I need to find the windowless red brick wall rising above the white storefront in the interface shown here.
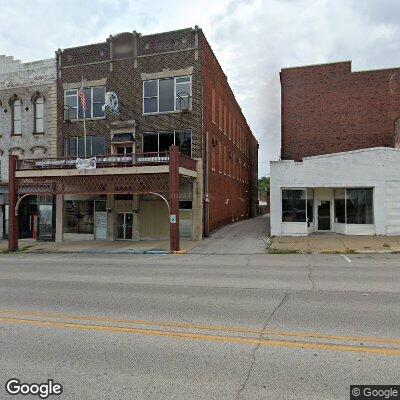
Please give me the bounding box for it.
[280,61,400,161]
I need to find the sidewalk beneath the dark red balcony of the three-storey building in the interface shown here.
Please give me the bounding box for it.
[0,239,198,254]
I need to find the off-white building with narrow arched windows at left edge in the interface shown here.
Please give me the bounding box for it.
[0,56,56,239]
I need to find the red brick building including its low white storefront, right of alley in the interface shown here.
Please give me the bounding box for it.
[271,62,400,236]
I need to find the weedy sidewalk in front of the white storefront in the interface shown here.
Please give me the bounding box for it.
[267,234,400,253]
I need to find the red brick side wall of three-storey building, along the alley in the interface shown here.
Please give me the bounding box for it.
[201,35,258,230]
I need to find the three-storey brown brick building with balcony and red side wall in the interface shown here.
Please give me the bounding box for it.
[9,27,258,250]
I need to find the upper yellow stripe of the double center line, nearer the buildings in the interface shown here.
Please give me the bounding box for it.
[0,310,400,344]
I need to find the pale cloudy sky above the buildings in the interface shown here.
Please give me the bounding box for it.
[0,0,400,175]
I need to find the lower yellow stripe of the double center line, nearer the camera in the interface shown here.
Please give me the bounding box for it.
[0,317,400,356]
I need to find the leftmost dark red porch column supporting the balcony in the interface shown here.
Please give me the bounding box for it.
[8,155,19,252]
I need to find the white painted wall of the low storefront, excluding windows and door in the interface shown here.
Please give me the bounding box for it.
[271,147,400,236]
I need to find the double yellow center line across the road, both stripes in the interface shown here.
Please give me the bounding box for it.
[0,310,400,356]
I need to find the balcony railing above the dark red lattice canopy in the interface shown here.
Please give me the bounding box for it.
[17,151,196,171]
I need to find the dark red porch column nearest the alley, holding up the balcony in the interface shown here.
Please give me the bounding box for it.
[169,146,180,251]
